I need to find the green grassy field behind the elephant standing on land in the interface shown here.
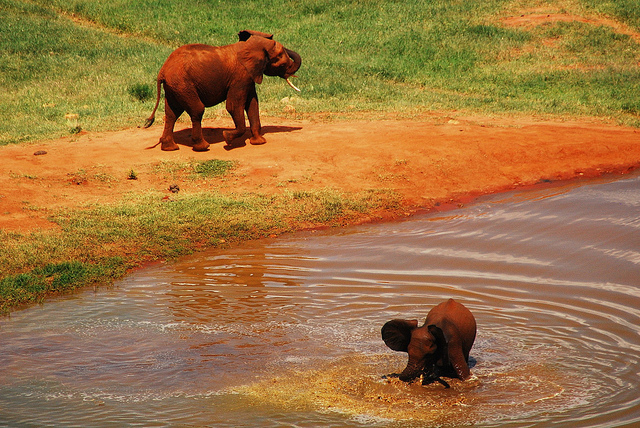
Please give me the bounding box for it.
[0,0,640,144]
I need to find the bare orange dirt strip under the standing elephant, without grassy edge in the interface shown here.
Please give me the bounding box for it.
[0,113,640,232]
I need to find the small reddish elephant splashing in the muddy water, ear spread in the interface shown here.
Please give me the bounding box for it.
[382,299,476,387]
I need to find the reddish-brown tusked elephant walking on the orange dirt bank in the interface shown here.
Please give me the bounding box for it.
[144,30,302,151]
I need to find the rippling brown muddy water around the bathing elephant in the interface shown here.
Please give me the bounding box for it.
[0,175,640,427]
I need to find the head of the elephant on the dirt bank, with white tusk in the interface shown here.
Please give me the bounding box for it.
[238,30,302,91]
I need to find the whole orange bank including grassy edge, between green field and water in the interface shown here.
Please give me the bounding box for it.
[0,112,640,312]
